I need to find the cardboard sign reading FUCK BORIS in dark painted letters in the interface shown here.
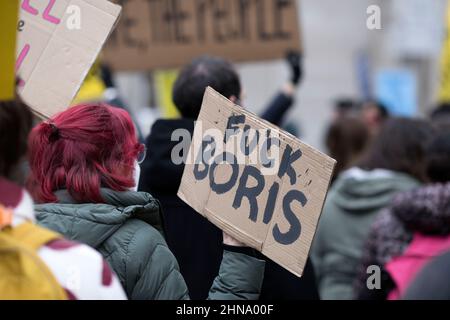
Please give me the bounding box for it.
[178,88,336,276]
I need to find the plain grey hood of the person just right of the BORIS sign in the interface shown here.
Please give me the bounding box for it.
[333,168,419,213]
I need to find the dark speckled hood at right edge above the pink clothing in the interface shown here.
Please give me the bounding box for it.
[391,183,450,235]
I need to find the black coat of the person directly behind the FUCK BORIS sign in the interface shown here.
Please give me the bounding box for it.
[139,95,319,300]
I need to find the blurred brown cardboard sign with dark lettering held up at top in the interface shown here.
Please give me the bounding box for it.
[104,0,301,71]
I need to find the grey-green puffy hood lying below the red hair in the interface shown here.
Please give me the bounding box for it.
[35,189,162,248]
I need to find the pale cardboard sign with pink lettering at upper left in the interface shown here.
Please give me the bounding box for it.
[16,0,121,118]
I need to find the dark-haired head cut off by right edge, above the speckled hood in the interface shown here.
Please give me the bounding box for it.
[426,130,450,183]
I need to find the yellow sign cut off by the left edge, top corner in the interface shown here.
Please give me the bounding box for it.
[0,0,19,100]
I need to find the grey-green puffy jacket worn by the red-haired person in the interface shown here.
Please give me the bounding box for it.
[35,189,264,300]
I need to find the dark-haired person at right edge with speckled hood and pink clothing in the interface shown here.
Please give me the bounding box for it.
[356,131,450,300]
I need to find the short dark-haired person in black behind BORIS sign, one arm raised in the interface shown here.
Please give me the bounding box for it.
[139,53,319,300]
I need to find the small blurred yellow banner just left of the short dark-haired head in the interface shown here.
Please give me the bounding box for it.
[154,70,180,119]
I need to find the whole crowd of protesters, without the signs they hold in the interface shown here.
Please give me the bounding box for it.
[0,52,450,301]
